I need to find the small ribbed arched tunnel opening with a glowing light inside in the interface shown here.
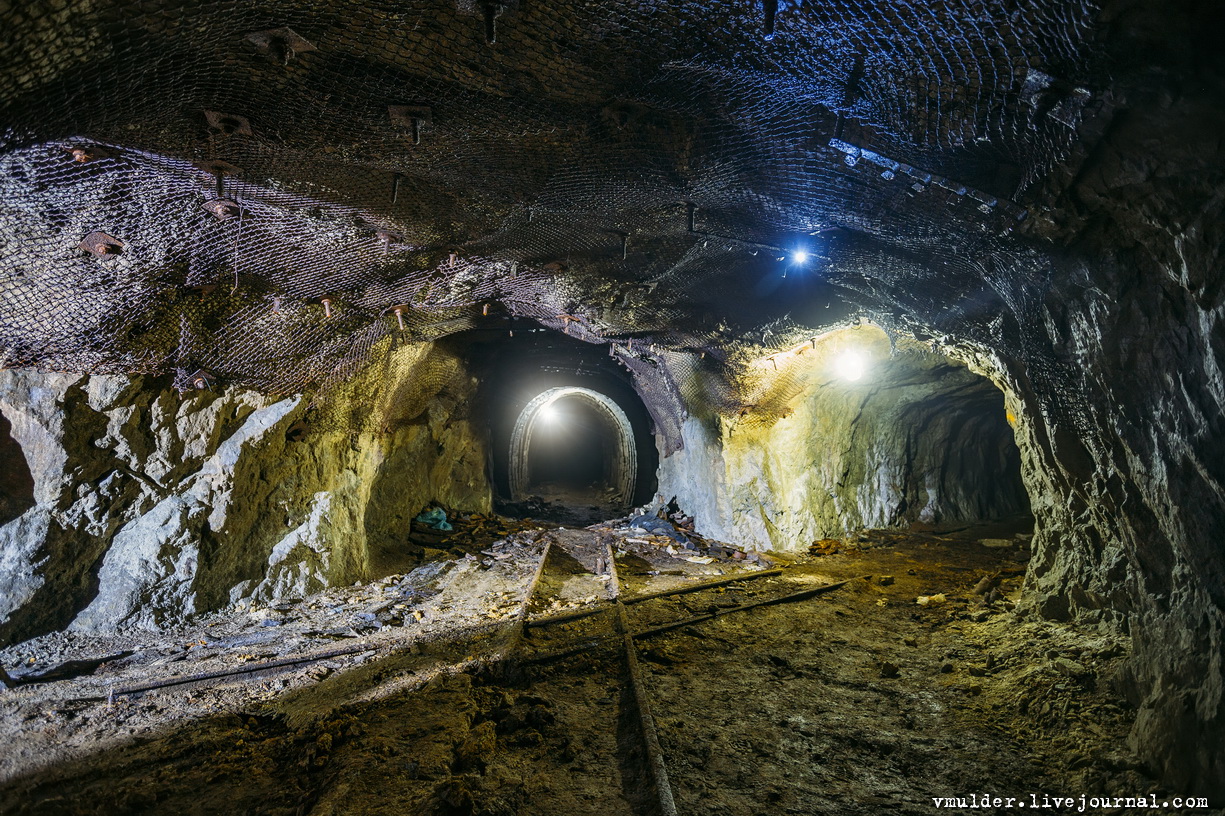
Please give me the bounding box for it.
[508,386,638,510]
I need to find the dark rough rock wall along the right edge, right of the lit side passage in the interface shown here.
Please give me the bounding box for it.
[1008,95,1225,789]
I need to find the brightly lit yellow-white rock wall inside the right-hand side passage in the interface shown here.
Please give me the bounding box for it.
[659,327,1028,550]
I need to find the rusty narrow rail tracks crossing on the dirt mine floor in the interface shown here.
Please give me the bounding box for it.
[19,524,854,816]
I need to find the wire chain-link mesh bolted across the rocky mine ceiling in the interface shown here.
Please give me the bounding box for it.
[0,0,1096,424]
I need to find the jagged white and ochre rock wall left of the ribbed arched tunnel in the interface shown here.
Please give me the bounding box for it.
[0,344,490,642]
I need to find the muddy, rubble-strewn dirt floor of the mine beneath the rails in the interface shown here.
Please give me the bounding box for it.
[0,514,1185,816]
